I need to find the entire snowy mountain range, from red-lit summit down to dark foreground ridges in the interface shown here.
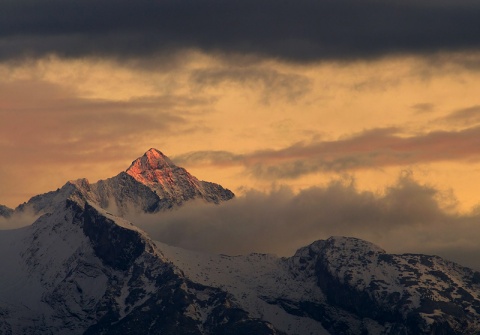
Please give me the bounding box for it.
[0,149,480,335]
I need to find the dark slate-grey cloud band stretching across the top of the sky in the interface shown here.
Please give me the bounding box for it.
[0,0,480,61]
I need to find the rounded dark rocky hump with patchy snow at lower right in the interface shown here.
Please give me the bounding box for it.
[291,237,480,334]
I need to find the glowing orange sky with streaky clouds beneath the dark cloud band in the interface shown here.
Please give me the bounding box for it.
[0,51,480,211]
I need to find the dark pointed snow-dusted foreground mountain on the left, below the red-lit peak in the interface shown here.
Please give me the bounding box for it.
[0,196,279,334]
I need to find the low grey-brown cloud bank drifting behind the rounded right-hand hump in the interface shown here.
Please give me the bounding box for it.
[131,174,480,269]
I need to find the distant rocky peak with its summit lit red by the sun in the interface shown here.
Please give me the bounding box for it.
[16,148,234,215]
